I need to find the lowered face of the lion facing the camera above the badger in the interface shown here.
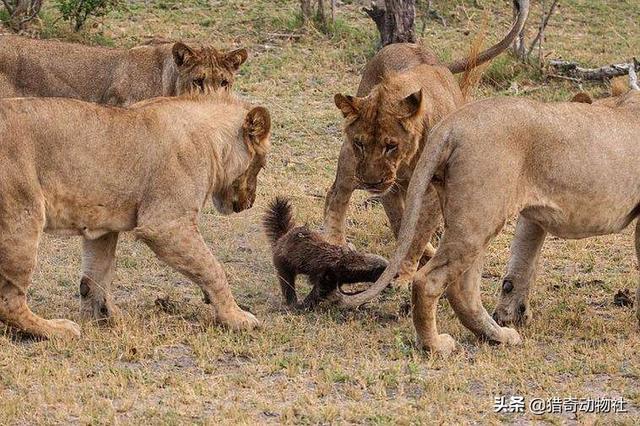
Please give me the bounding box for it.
[334,90,424,194]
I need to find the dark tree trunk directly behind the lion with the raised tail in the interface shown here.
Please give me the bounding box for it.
[364,0,416,46]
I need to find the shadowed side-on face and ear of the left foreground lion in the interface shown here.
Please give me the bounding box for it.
[213,107,271,214]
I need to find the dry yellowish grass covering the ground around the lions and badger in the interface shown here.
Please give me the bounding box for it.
[0,0,640,424]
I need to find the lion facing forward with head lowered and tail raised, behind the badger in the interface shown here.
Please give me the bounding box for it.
[324,0,529,272]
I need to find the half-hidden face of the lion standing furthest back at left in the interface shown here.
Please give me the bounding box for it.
[172,43,247,95]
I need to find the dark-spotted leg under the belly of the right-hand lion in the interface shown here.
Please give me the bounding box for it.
[493,216,547,325]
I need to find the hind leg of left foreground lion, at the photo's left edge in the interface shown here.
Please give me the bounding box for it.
[0,197,80,338]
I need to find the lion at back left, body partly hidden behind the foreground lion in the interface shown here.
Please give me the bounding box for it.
[0,35,247,106]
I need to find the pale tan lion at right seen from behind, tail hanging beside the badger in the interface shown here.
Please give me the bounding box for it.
[341,85,640,354]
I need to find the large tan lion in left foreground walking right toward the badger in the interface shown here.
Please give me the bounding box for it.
[0,95,271,336]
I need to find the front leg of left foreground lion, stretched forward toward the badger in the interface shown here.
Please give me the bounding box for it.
[135,216,258,330]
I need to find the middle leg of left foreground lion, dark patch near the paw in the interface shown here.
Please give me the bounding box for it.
[80,232,118,320]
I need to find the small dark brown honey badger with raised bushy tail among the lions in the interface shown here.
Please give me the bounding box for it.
[263,197,388,309]
